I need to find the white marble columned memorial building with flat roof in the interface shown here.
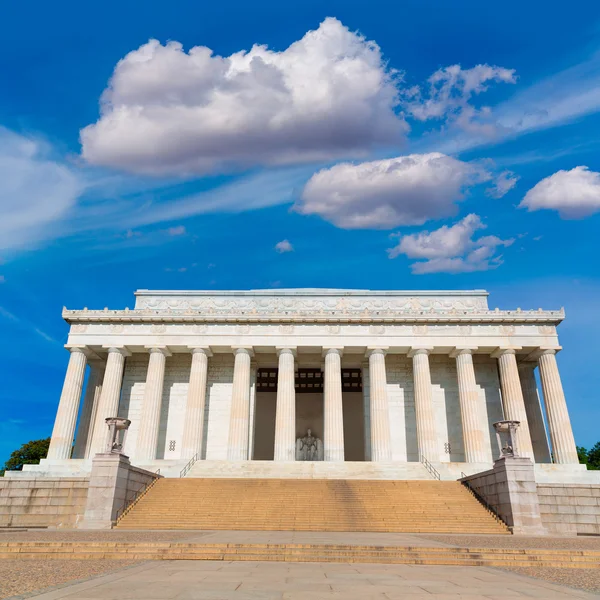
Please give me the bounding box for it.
[36,289,578,478]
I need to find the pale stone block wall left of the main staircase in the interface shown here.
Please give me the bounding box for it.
[0,477,89,527]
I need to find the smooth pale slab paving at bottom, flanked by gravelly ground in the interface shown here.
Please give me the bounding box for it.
[14,561,600,600]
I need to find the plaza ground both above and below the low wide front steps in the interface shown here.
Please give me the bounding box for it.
[0,530,600,600]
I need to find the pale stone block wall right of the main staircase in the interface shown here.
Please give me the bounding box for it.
[537,483,600,535]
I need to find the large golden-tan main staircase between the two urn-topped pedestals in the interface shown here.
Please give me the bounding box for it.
[117,478,509,534]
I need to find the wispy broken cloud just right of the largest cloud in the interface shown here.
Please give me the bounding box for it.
[403,65,516,135]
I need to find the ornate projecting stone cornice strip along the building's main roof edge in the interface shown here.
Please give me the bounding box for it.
[62,308,565,325]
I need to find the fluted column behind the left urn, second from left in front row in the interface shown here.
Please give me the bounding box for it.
[90,348,129,457]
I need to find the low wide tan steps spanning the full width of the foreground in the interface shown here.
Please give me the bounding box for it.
[0,542,600,569]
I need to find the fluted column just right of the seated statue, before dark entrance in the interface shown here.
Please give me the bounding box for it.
[323,348,344,461]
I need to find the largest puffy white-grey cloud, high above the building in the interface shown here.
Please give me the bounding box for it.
[81,18,407,175]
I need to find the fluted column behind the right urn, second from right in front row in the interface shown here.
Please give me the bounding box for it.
[492,348,534,460]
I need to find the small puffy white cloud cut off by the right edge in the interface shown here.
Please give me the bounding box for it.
[519,166,600,219]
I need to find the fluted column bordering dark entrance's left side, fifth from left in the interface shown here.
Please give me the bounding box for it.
[227,348,252,460]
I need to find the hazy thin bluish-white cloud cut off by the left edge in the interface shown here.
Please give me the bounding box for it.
[0,127,83,249]
